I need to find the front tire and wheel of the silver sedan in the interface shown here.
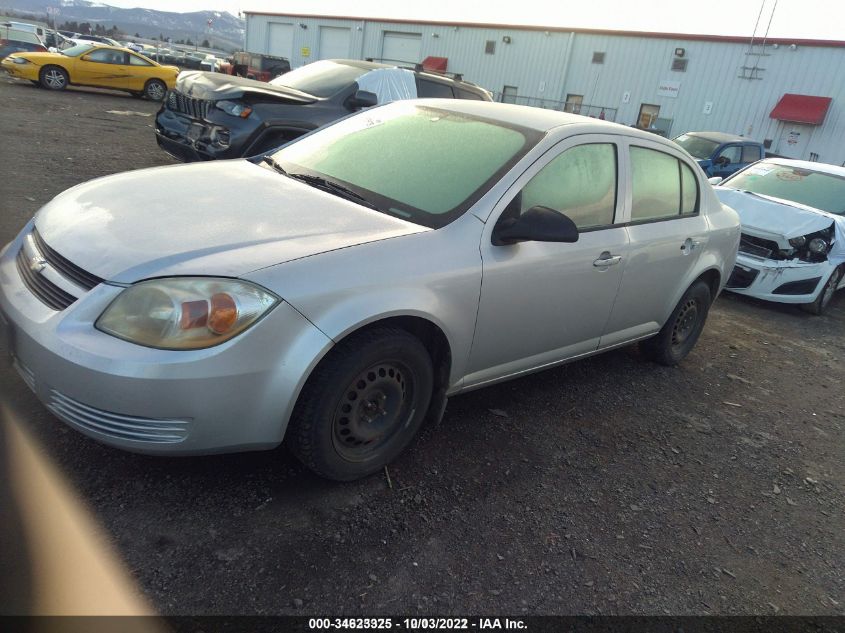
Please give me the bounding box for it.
[286,328,433,481]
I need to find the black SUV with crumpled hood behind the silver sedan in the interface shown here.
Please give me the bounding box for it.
[155,59,492,161]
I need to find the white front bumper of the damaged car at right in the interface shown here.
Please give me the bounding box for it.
[725,252,835,304]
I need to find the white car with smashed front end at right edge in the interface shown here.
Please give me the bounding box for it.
[711,158,845,314]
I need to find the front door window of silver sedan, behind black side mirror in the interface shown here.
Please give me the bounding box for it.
[506,143,616,230]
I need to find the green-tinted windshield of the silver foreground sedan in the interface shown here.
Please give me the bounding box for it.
[273,101,542,228]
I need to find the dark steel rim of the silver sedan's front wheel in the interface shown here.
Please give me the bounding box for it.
[332,361,416,462]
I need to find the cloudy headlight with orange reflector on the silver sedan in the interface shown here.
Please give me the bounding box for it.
[95,277,280,350]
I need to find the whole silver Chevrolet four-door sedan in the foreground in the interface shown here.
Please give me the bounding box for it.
[0,100,740,480]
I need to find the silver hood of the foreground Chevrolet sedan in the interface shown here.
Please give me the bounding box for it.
[35,160,431,283]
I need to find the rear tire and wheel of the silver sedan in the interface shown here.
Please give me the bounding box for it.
[640,281,711,367]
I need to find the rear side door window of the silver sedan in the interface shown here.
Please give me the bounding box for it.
[631,147,698,222]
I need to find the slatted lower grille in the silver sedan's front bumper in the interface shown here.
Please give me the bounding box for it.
[47,389,191,444]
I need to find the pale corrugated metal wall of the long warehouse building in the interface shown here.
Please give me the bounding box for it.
[246,14,845,165]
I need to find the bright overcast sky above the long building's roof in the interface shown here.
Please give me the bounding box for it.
[103,0,845,40]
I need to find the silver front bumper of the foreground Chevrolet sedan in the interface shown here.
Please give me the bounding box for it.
[0,230,331,455]
